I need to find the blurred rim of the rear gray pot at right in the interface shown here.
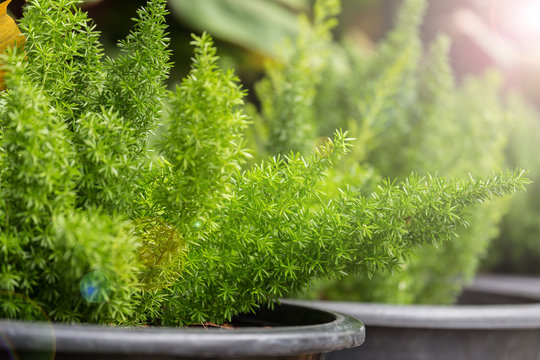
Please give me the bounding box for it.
[288,275,540,330]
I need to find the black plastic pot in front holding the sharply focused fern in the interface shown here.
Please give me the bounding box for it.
[0,303,365,360]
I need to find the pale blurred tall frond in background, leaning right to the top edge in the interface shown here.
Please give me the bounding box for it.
[348,0,427,164]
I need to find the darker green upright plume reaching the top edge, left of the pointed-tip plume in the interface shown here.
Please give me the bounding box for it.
[99,0,171,151]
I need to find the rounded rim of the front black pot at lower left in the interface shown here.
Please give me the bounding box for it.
[0,302,365,357]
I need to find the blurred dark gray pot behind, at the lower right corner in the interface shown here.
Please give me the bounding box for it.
[292,275,540,360]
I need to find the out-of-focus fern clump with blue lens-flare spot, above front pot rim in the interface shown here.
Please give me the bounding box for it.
[49,211,141,323]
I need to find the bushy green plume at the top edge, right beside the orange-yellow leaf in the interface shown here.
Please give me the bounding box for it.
[20,0,103,121]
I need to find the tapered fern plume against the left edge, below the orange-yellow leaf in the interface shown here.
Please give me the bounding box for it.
[0,54,79,234]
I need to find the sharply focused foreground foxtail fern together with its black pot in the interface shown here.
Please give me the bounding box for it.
[0,0,526,358]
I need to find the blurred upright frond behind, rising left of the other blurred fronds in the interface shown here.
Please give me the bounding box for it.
[252,0,340,155]
